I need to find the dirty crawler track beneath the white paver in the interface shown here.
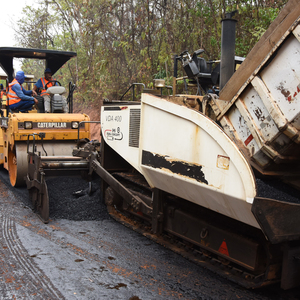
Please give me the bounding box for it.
[105,172,300,288]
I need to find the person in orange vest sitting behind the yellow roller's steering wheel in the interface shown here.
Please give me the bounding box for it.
[33,68,69,113]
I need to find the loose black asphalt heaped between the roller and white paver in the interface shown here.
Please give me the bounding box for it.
[46,177,109,221]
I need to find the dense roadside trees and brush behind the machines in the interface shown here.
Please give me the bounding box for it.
[16,0,287,104]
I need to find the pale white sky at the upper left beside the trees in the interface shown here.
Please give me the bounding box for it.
[0,0,38,73]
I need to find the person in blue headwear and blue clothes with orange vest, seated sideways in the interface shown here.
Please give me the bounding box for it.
[7,71,38,112]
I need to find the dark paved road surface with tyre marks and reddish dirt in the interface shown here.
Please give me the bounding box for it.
[0,170,300,300]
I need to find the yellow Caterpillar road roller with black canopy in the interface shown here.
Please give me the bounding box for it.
[0,47,90,187]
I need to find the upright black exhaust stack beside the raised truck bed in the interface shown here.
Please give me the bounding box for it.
[219,10,237,90]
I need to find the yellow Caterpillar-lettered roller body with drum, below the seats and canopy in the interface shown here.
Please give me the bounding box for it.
[0,112,90,186]
